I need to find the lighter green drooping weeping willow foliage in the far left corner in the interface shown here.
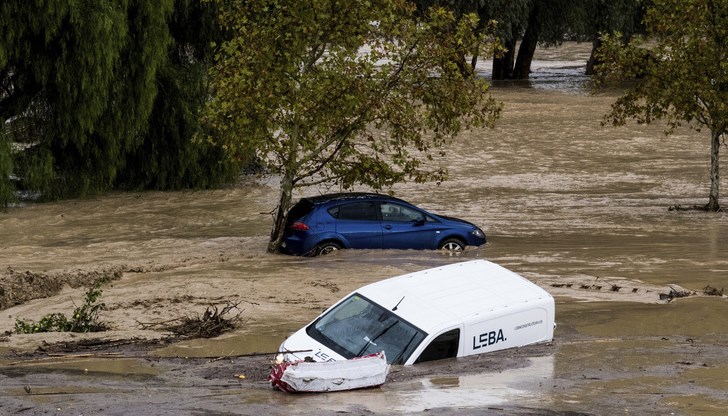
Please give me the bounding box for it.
[0,0,173,198]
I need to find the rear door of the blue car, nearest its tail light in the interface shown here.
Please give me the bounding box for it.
[329,201,382,248]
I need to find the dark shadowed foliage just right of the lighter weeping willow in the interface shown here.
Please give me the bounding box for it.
[116,0,243,190]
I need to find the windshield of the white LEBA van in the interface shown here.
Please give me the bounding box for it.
[306,293,427,364]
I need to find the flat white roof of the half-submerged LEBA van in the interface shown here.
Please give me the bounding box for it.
[357,260,553,333]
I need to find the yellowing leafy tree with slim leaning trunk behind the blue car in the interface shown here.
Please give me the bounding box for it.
[204,0,500,251]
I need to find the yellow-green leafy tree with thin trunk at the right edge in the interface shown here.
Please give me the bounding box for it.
[597,0,728,211]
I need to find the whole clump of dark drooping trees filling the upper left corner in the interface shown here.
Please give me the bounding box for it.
[0,0,240,205]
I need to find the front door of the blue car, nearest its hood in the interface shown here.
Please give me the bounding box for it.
[379,202,439,250]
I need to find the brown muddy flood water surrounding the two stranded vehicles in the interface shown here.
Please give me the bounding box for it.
[0,44,728,415]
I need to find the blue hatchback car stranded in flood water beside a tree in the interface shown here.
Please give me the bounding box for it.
[282,193,485,256]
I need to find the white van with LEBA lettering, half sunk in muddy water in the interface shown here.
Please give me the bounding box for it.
[279,260,555,365]
